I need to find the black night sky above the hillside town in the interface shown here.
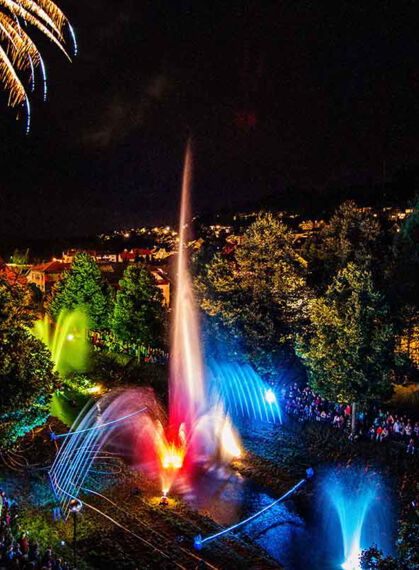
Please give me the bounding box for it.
[0,0,419,237]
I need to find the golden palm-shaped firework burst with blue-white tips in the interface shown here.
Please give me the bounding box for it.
[0,0,76,130]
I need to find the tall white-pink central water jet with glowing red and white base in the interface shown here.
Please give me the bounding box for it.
[159,140,246,490]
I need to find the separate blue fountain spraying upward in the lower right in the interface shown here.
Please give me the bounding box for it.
[320,467,391,570]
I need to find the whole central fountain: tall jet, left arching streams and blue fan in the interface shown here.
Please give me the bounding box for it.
[50,145,280,516]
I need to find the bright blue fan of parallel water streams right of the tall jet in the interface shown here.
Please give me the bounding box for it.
[207,360,282,423]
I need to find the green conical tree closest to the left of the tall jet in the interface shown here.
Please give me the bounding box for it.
[111,264,165,346]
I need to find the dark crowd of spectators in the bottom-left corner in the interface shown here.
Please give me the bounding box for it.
[0,489,72,570]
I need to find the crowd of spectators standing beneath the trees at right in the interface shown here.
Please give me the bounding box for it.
[283,383,419,455]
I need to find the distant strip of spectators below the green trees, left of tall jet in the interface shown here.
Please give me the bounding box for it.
[89,331,169,364]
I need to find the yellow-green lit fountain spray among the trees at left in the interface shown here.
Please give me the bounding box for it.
[33,309,88,375]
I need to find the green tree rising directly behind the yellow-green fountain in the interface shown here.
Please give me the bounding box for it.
[47,253,113,330]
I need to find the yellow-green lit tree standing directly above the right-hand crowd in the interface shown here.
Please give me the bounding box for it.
[297,263,395,404]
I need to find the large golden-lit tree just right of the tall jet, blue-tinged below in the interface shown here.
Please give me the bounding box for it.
[196,214,308,373]
